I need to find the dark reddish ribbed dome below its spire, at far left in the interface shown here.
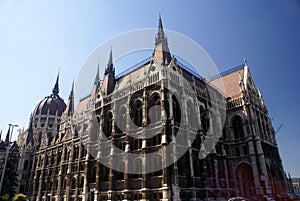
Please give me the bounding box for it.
[34,94,66,116]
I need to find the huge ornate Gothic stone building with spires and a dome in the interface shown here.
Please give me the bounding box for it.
[17,18,287,201]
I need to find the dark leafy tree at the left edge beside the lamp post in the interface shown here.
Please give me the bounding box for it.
[0,146,19,198]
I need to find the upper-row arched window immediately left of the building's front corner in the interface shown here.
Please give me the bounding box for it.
[148,93,161,123]
